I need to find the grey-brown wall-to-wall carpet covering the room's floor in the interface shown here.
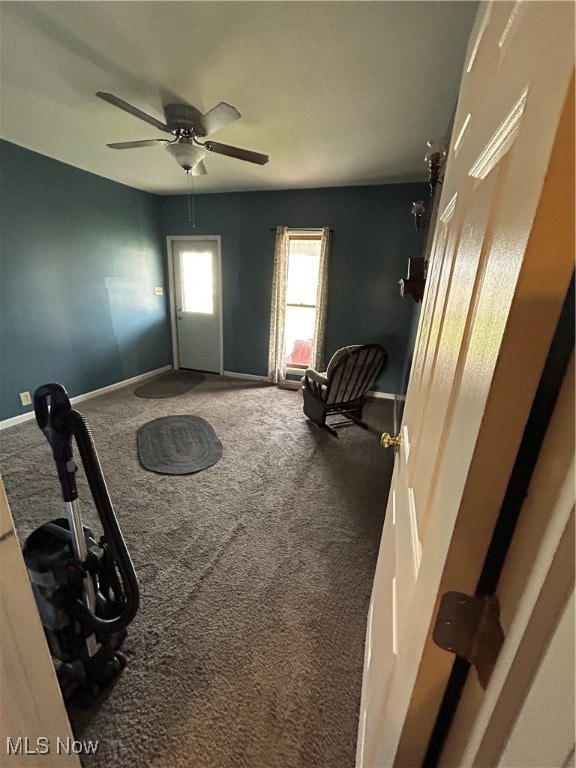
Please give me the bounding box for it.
[0,376,393,768]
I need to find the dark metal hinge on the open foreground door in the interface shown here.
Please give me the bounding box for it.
[432,592,504,688]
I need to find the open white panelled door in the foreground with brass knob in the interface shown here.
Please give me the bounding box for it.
[357,2,574,768]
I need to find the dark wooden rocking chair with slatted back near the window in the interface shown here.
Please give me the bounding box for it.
[302,344,388,435]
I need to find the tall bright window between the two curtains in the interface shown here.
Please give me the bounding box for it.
[284,233,321,369]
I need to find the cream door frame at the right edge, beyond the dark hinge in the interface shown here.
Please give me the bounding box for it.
[439,352,575,768]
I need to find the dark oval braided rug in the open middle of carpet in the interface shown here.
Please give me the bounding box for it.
[136,416,222,475]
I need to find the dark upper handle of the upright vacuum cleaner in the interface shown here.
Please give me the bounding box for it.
[34,384,78,501]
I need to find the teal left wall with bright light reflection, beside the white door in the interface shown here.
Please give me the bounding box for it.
[0,142,171,419]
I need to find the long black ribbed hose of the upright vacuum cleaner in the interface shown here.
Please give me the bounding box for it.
[58,409,140,632]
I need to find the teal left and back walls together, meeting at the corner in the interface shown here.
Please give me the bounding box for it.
[0,141,427,419]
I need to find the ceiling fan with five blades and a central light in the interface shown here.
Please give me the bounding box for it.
[96,91,268,176]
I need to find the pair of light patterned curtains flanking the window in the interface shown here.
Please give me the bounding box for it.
[268,227,330,384]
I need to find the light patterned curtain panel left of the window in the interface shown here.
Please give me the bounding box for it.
[268,227,289,384]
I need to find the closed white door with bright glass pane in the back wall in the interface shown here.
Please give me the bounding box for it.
[169,237,223,373]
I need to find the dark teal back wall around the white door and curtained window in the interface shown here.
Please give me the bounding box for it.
[160,183,428,392]
